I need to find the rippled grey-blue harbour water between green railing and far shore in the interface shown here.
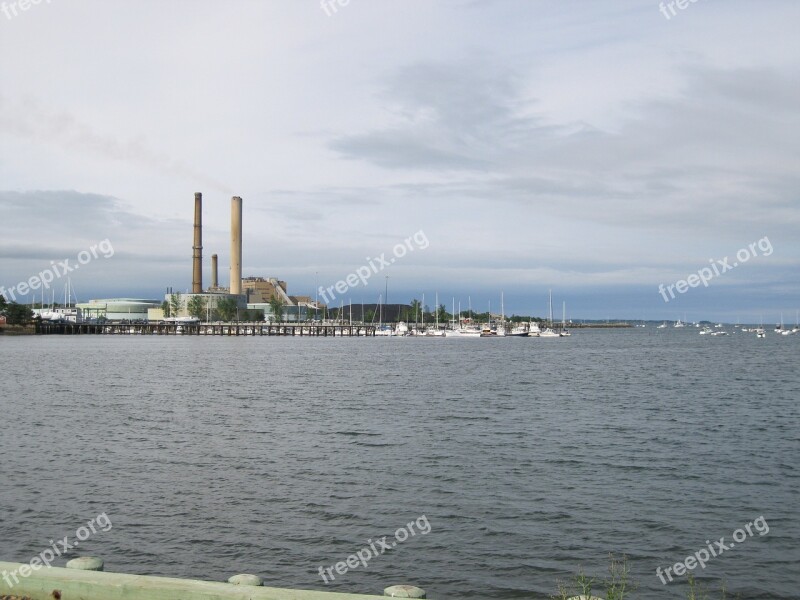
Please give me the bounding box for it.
[0,329,800,599]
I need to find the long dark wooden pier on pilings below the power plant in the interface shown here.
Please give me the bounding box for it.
[34,321,375,337]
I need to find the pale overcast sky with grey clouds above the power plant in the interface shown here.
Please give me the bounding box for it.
[0,0,800,323]
